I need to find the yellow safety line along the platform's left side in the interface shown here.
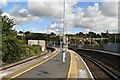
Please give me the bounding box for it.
[10,49,60,79]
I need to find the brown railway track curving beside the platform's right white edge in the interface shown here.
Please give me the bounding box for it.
[71,50,120,80]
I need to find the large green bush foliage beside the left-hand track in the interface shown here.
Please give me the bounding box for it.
[0,13,41,63]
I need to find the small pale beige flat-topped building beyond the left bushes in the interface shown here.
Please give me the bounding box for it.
[28,40,46,51]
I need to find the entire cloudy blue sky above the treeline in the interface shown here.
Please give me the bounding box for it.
[0,0,118,34]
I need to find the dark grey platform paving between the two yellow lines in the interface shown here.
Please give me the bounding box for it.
[12,51,70,80]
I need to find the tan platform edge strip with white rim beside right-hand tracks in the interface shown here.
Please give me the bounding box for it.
[67,50,93,80]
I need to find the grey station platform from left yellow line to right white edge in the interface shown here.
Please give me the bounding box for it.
[2,50,93,80]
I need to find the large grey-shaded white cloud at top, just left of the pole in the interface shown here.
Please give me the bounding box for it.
[28,0,63,18]
